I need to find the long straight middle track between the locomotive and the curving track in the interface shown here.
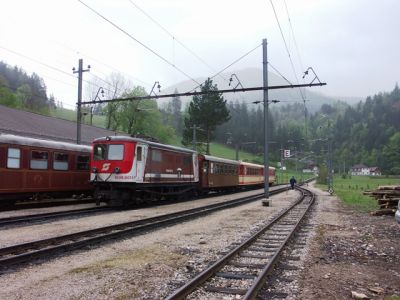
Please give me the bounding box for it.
[0,187,287,271]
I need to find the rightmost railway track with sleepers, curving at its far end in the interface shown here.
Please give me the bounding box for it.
[167,187,314,300]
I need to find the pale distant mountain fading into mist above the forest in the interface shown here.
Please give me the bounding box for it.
[160,68,361,112]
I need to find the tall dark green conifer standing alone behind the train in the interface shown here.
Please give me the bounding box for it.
[182,78,230,154]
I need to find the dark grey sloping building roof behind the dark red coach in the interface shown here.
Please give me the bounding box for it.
[0,105,120,145]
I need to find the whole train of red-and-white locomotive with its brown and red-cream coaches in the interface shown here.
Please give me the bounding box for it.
[91,136,275,206]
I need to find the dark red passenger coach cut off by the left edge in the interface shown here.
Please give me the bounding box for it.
[0,134,92,204]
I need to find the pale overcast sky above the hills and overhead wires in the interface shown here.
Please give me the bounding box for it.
[0,0,400,108]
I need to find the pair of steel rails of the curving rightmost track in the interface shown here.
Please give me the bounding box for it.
[166,187,314,300]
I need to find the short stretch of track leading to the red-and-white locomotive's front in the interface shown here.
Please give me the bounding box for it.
[0,207,115,227]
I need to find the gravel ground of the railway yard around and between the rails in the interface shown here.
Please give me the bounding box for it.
[0,184,400,299]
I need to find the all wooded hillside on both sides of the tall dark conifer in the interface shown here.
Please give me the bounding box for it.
[0,62,400,175]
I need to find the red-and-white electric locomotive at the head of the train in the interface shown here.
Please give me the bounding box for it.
[91,136,199,205]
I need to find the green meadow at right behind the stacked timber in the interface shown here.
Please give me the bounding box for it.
[319,176,400,212]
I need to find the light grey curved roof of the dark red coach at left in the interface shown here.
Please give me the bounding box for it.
[0,134,92,152]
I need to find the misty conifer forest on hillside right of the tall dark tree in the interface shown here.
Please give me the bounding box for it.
[216,85,400,174]
